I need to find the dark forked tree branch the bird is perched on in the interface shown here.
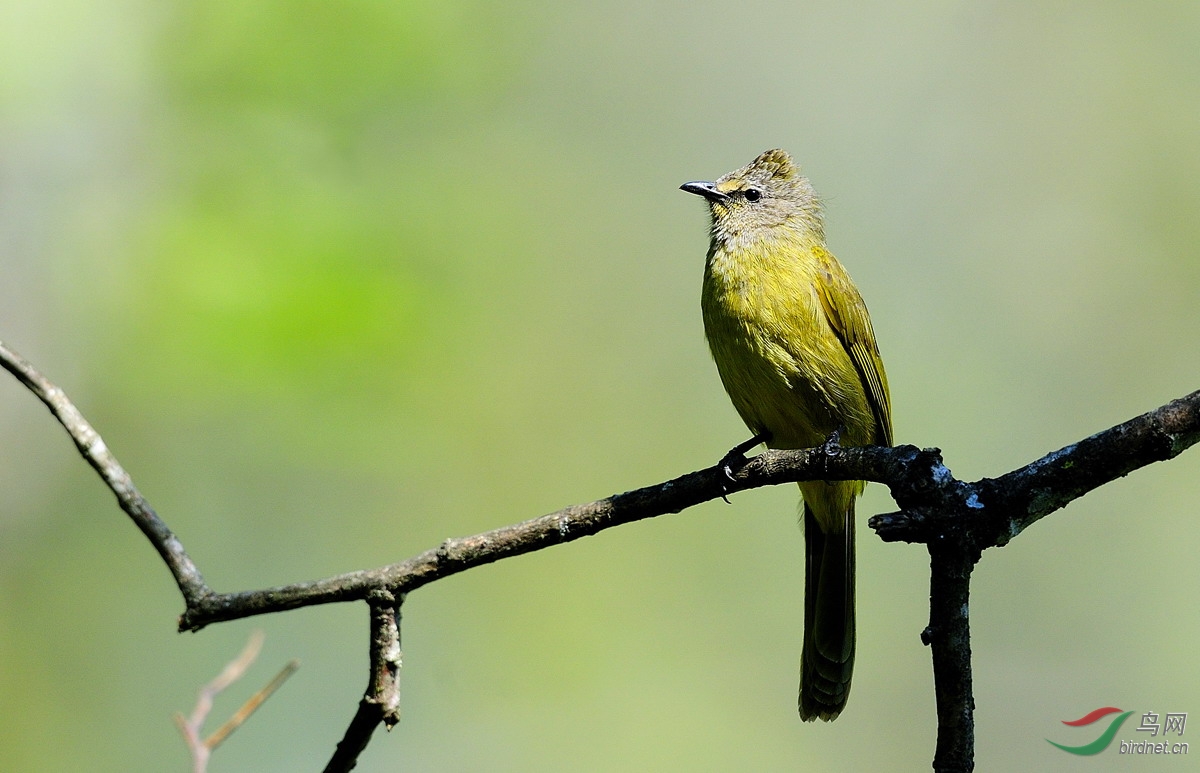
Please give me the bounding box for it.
[0,343,1200,772]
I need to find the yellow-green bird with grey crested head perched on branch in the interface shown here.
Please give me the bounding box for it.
[680,150,892,720]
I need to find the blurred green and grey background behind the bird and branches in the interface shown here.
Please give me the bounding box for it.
[0,0,1200,773]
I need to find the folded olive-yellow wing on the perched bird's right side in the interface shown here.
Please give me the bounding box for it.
[812,246,892,445]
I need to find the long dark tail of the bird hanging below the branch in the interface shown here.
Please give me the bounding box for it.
[800,499,854,721]
